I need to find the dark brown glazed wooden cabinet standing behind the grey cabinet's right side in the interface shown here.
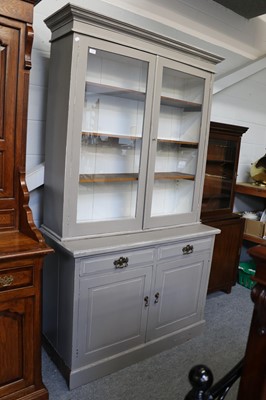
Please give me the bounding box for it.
[201,122,248,293]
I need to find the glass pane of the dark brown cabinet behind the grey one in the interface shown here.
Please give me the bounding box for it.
[202,139,236,211]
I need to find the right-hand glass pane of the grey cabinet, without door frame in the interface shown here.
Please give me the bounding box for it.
[151,68,205,216]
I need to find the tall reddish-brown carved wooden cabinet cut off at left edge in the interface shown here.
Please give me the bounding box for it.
[0,0,51,400]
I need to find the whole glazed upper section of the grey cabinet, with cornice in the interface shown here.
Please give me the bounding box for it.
[44,5,220,238]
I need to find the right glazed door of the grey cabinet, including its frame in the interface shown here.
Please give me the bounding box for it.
[145,59,209,227]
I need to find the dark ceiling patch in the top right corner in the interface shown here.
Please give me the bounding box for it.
[214,0,266,19]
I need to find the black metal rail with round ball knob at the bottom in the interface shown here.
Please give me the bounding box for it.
[184,359,244,400]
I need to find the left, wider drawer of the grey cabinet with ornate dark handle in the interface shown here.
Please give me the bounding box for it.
[80,249,154,276]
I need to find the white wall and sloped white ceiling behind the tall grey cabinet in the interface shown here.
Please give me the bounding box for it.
[26,0,266,225]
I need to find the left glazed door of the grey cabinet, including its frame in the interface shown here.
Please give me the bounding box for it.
[70,40,154,234]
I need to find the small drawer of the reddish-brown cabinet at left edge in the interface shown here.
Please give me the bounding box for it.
[0,266,33,292]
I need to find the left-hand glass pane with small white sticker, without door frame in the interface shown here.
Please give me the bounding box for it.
[77,48,148,222]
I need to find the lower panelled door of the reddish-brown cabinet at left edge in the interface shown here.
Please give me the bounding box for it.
[0,297,34,398]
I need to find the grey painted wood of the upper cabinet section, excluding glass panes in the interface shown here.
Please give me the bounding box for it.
[41,6,218,239]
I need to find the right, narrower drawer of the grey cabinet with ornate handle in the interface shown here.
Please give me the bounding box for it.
[158,238,213,260]
